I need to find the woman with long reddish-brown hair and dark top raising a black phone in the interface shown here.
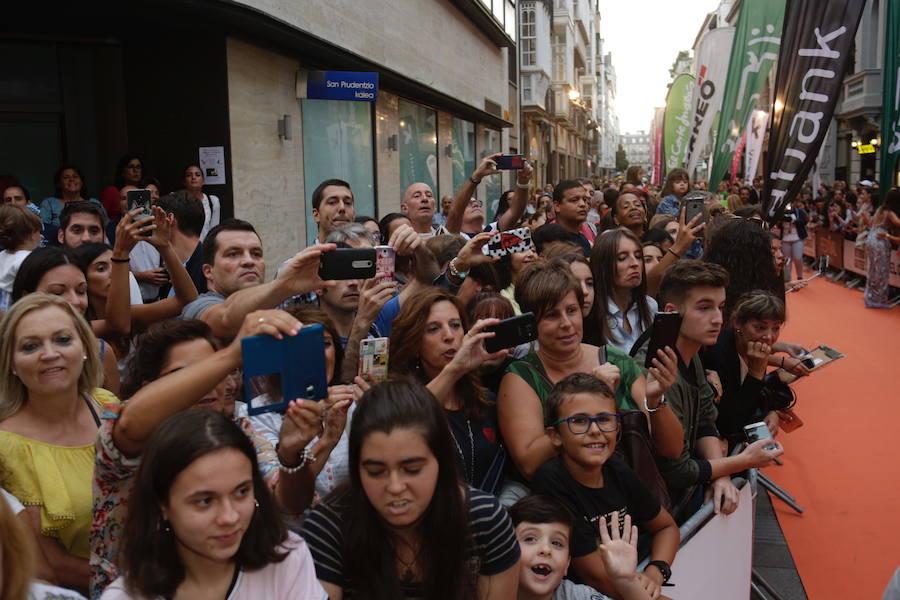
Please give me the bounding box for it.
[388,288,508,494]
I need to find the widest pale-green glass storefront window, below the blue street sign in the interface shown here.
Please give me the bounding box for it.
[300,100,376,244]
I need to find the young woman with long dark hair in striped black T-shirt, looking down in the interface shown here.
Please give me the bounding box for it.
[303,380,519,600]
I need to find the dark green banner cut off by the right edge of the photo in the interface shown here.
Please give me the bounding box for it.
[878,0,900,200]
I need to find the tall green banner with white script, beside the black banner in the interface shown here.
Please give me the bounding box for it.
[709,0,785,190]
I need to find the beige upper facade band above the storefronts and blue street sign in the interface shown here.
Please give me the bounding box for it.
[232,0,509,116]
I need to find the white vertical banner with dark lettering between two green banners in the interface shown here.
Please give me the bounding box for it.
[687,27,734,177]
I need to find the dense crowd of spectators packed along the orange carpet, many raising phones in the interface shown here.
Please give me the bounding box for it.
[0,155,900,600]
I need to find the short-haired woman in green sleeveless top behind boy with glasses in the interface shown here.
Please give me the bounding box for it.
[497,262,683,488]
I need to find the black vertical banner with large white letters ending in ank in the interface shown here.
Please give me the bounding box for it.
[762,0,866,223]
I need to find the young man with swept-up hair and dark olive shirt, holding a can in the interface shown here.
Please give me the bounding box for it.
[634,260,784,514]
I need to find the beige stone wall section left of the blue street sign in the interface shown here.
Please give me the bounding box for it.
[227,38,315,279]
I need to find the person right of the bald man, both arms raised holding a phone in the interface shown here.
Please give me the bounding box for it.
[438,152,534,239]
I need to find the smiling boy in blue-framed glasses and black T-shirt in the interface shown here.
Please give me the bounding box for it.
[532,373,680,597]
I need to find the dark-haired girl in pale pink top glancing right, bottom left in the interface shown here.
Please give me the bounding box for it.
[101,409,327,600]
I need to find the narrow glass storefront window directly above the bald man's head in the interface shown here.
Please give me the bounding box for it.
[399,100,440,198]
